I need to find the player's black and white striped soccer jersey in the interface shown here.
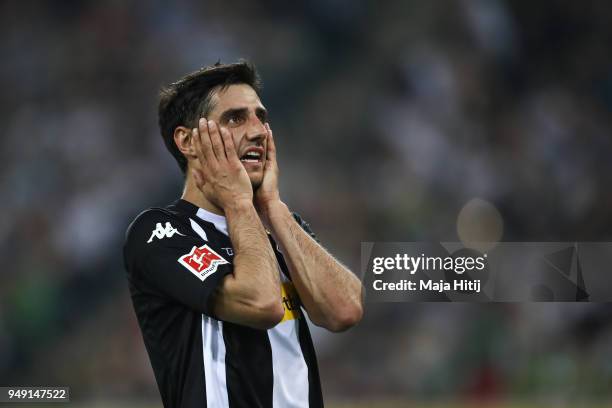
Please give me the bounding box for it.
[124,200,323,408]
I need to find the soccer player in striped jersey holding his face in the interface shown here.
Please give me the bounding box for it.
[124,62,363,408]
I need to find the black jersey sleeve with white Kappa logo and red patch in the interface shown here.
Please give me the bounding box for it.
[124,210,233,317]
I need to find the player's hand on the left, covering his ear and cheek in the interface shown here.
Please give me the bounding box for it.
[191,118,253,209]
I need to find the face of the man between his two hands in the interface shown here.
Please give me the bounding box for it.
[207,84,268,190]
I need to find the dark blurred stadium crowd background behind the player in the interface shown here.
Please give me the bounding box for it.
[0,0,612,407]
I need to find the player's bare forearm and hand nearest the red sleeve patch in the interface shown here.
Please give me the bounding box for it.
[192,120,284,329]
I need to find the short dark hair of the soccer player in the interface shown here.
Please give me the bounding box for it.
[158,60,261,174]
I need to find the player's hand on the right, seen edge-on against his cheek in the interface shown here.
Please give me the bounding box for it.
[253,123,282,225]
